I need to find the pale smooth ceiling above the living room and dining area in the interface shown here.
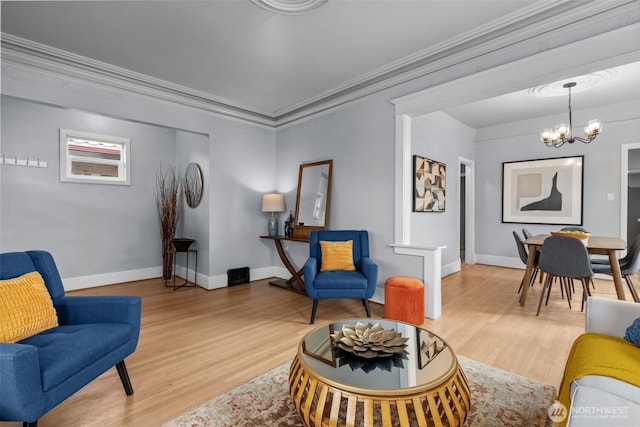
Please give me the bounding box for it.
[1,0,640,128]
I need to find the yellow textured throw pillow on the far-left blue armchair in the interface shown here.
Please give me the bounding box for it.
[0,271,58,342]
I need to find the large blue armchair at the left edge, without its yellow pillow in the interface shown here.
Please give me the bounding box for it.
[0,251,141,426]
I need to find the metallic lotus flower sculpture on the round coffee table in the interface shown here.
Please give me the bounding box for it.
[331,322,409,359]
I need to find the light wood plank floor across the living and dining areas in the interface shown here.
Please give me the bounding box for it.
[0,265,638,427]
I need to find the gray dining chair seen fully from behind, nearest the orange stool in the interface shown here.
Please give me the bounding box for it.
[536,236,593,316]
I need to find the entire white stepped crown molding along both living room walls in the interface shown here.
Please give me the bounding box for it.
[1,0,638,128]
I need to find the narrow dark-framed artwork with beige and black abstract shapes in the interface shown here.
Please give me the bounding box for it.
[413,155,447,212]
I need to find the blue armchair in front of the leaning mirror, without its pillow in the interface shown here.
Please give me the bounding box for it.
[303,230,378,324]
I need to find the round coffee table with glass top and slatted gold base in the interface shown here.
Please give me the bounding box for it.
[289,318,471,427]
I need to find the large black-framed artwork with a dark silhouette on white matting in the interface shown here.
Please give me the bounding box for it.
[502,156,584,225]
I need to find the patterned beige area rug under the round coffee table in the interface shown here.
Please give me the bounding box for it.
[163,356,556,427]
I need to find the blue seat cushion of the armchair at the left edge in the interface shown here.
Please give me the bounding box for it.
[20,323,133,392]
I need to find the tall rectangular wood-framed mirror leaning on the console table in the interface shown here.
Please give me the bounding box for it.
[293,160,333,237]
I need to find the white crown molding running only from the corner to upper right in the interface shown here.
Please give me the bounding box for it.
[274,0,639,127]
